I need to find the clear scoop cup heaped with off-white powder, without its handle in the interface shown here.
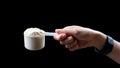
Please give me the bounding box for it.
[24,28,45,50]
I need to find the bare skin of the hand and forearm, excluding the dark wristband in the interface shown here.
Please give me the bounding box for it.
[54,25,120,64]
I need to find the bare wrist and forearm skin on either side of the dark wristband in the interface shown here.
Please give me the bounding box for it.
[95,32,120,64]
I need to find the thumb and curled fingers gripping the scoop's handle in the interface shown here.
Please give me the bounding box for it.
[54,28,85,51]
